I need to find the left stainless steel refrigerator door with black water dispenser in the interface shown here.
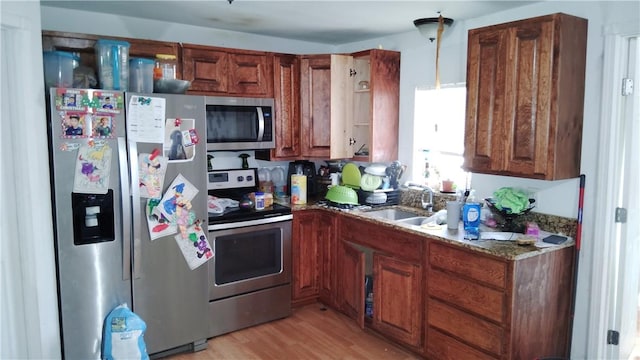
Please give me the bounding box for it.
[48,89,132,359]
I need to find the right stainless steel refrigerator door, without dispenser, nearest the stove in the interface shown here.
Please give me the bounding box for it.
[126,93,207,354]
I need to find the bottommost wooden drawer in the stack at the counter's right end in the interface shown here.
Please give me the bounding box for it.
[427,327,498,360]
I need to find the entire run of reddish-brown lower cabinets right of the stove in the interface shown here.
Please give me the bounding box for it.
[292,209,574,360]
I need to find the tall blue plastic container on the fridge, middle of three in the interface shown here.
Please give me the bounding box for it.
[95,39,130,91]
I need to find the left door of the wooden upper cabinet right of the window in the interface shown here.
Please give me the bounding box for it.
[464,26,508,173]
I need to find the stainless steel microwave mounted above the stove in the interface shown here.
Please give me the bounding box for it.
[206,96,275,151]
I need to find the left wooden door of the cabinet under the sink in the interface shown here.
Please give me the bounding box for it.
[337,241,364,328]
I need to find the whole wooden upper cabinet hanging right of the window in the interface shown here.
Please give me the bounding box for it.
[464,14,587,180]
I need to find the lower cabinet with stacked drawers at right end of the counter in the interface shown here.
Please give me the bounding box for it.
[425,239,573,359]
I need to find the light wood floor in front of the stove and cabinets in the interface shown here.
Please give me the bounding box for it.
[169,304,419,360]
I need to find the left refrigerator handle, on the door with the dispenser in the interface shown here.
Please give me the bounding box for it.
[118,137,131,280]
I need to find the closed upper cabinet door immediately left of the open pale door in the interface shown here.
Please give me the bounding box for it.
[300,55,331,158]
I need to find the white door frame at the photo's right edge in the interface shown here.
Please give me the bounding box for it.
[583,23,640,359]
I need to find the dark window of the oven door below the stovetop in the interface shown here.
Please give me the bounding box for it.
[214,228,282,285]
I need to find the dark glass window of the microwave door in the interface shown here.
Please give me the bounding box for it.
[207,105,258,143]
